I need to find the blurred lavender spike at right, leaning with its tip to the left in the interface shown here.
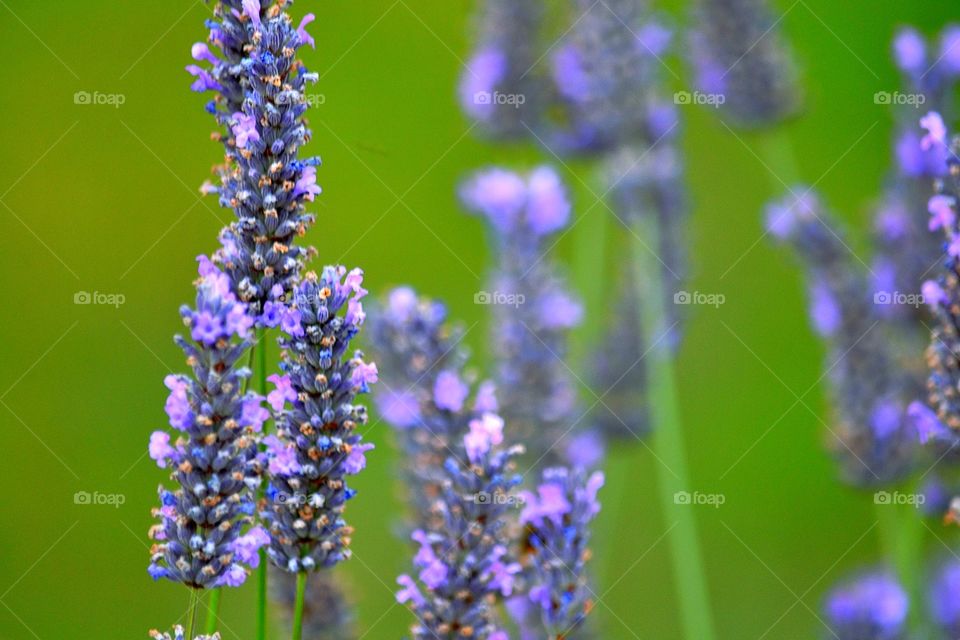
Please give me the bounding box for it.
[767,187,919,486]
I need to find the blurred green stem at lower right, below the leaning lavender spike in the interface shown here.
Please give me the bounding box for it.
[874,489,927,638]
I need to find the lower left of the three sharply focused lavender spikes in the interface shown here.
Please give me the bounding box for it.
[149,256,269,589]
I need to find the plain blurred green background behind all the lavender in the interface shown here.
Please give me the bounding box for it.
[0,0,957,640]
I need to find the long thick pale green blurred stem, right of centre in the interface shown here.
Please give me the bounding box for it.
[630,216,715,640]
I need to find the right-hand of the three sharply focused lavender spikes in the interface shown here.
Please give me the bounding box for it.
[260,267,377,573]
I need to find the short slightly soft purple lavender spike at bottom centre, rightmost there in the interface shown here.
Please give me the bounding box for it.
[520,467,603,640]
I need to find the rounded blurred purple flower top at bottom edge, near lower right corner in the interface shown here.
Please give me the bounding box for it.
[824,573,909,640]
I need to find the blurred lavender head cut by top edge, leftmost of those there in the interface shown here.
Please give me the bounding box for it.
[459,0,544,138]
